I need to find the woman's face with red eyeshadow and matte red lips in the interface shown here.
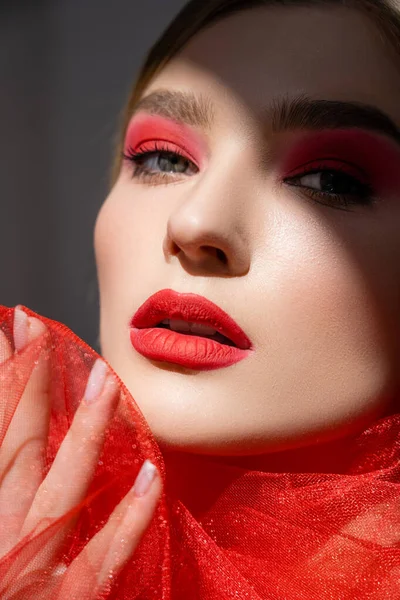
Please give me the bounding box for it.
[95,7,400,455]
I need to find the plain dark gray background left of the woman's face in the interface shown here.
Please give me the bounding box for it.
[0,0,185,347]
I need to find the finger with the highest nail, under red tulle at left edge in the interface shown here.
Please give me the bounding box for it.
[0,307,49,552]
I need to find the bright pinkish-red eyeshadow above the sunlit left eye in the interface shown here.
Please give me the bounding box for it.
[124,113,208,168]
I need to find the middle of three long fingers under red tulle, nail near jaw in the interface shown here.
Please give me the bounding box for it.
[21,359,119,535]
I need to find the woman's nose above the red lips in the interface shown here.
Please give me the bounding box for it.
[163,168,251,277]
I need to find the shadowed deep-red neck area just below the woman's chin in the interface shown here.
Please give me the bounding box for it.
[163,395,398,518]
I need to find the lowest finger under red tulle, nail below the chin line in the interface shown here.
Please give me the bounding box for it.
[57,460,162,600]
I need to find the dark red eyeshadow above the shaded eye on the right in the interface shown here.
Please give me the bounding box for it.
[281,129,400,193]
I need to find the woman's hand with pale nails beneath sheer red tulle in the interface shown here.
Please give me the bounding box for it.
[0,308,162,600]
